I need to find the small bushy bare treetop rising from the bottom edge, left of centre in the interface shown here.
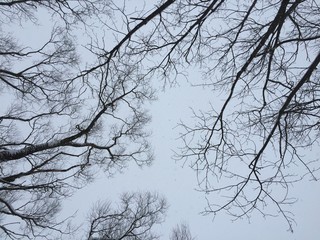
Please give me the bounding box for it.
[88,192,167,240]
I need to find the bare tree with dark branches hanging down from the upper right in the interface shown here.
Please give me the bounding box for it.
[149,0,320,232]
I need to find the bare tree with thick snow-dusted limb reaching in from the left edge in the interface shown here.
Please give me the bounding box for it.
[0,0,165,239]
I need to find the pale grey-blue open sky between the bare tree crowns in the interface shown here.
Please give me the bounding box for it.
[3,0,320,240]
